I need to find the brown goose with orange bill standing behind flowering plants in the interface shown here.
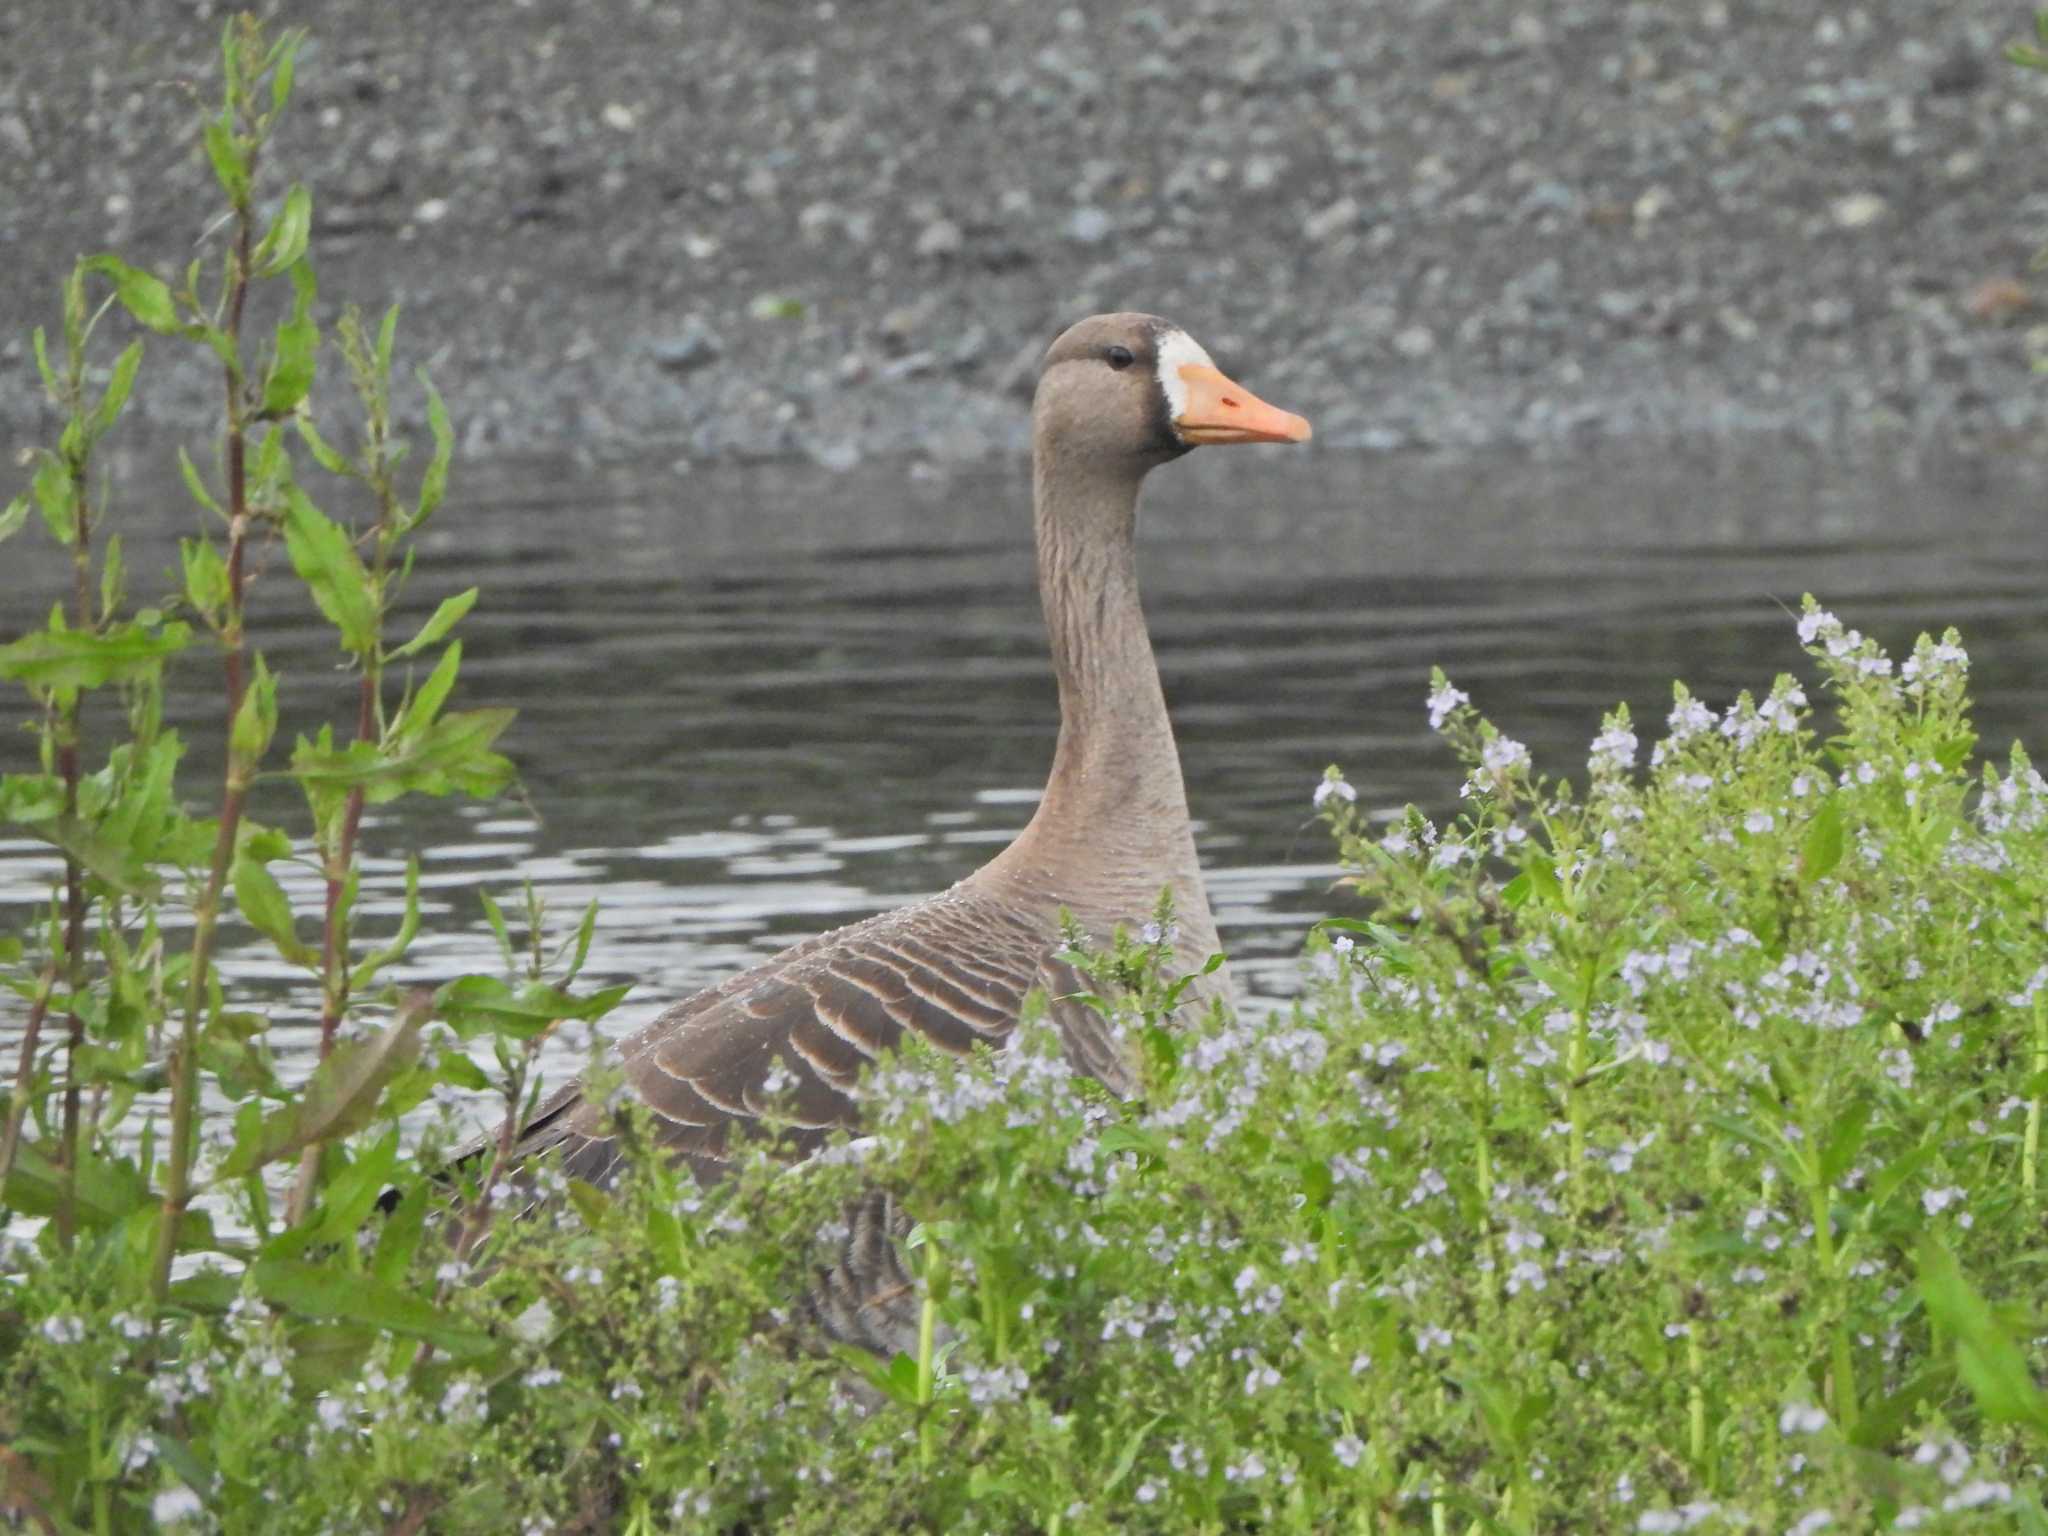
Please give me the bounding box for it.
[497,313,1309,1236]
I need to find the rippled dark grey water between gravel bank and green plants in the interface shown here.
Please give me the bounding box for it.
[0,453,2048,1081]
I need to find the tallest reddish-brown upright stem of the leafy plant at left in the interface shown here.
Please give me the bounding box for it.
[150,189,254,1300]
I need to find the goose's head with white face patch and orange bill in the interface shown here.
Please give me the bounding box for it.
[1032,313,1309,475]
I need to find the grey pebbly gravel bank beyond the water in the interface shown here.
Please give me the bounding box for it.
[0,0,2048,465]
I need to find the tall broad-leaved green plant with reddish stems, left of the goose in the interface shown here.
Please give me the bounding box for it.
[0,18,623,1530]
